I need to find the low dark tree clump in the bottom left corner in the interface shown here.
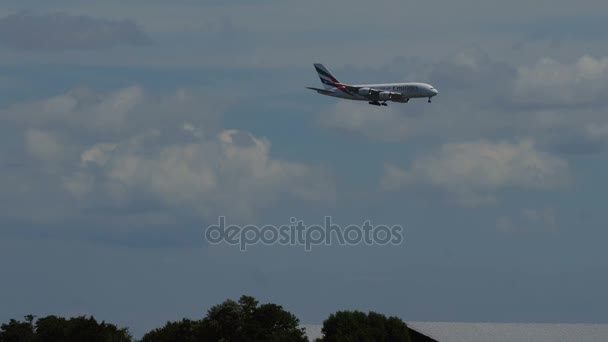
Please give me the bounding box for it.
[0,316,133,342]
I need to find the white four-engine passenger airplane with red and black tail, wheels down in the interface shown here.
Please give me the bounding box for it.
[306,63,439,106]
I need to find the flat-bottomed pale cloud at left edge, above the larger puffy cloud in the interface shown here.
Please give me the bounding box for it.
[0,85,229,144]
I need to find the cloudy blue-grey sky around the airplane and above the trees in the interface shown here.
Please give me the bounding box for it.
[0,0,608,336]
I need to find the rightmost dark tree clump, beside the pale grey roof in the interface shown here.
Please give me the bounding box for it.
[317,311,410,342]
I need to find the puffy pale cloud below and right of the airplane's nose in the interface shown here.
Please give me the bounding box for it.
[382,140,570,205]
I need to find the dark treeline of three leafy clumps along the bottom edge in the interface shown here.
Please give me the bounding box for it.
[0,296,416,342]
